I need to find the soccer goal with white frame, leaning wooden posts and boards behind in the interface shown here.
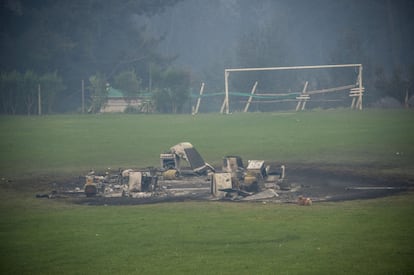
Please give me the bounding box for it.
[220,64,364,114]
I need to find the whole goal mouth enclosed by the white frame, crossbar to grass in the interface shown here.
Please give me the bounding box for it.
[220,64,364,114]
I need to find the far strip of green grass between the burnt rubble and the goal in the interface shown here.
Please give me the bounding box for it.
[0,110,414,176]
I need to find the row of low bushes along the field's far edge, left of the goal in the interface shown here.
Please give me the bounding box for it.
[0,67,191,115]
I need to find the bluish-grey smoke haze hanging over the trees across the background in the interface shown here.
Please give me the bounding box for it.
[0,0,414,113]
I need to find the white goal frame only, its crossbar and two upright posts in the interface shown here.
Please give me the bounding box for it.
[220,64,364,114]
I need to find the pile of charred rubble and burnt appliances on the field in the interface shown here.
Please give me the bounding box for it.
[39,142,309,205]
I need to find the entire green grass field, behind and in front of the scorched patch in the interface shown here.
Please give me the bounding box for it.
[0,110,414,274]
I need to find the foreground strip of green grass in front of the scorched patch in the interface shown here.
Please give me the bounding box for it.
[0,191,414,274]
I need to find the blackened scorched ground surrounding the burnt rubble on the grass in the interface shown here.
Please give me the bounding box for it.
[0,165,414,205]
